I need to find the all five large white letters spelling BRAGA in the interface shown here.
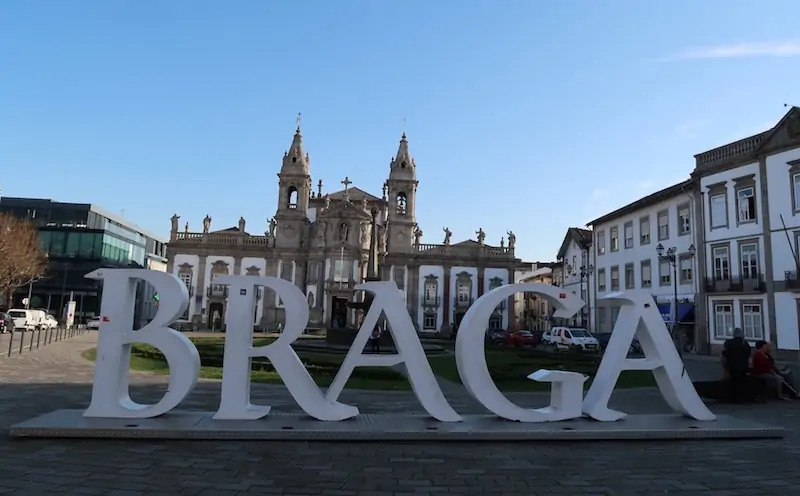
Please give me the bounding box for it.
[84,269,714,422]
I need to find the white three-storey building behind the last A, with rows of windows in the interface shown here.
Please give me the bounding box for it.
[588,180,697,344]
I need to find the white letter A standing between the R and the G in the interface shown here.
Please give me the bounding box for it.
[327,281,461,422]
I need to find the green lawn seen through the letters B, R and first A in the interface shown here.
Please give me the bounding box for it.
[83,338,410,391]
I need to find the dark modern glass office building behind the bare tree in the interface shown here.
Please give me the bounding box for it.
[0,197,166,322]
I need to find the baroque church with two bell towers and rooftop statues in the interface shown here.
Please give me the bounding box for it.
[167,126,521,335]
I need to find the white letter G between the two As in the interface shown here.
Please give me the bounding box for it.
[456,283,585,422]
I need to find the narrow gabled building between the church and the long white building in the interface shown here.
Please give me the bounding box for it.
[557,227,594,327]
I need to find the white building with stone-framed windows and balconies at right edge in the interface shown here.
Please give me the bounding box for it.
[692,107,800,358]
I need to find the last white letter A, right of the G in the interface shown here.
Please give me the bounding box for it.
[583,291,716,422]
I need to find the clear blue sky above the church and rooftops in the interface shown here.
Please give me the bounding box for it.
[0,0,800,260]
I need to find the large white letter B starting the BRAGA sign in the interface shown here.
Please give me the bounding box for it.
[83,269,200,418]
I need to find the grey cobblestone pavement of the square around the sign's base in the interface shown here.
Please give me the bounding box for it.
[0,333,800,496]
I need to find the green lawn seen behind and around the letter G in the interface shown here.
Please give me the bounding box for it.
[429,349,655,391]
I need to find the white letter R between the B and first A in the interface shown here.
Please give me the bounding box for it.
[214,276,358,420]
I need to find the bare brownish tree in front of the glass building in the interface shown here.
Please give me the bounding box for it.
[0,213,47,308]
